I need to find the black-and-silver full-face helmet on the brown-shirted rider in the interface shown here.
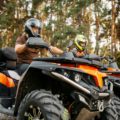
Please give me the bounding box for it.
[24,18,42,37]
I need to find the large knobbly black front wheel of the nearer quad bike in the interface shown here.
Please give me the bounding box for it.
[17,90,69,120]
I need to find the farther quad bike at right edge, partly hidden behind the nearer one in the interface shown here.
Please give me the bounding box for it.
[82,55,120,120]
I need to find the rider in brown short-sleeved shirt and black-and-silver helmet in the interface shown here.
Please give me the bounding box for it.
[15,18,63,74]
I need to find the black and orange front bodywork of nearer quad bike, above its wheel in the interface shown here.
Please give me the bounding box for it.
[15,57,110,114]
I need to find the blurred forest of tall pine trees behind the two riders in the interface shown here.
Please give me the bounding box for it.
[0,0,120,64]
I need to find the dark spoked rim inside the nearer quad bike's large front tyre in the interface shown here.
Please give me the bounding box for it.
[24,105,44,120]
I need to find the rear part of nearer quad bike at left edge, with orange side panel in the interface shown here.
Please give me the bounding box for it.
[0,48,20,115]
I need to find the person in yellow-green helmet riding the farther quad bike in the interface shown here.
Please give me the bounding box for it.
[68,34,87,57]
